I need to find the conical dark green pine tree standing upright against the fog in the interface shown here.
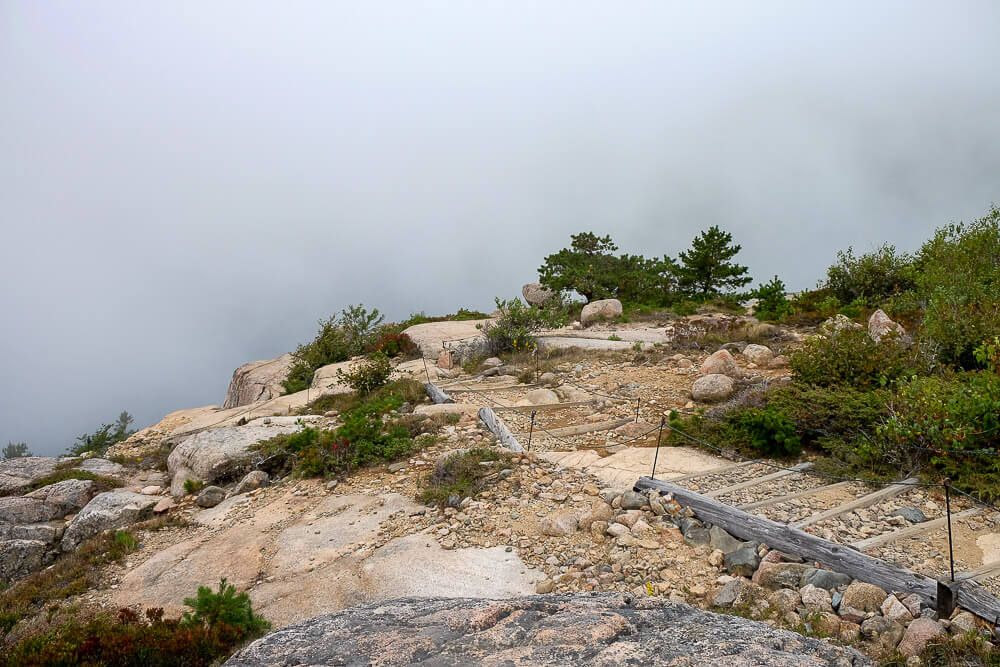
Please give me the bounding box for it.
[677,226,751,298]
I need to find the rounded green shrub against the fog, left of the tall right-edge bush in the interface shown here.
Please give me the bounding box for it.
[824,245,916,304]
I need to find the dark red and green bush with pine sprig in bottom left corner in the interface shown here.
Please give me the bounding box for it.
[2,579,270,667]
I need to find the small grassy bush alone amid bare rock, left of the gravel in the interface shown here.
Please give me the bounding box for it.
[418,447,511,507]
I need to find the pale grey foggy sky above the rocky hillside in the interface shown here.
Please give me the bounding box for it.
[0,0,1000,454]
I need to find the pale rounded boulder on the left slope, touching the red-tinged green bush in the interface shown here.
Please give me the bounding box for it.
[167,423,301,496]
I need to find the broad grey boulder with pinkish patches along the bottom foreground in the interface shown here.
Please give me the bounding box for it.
[225,593,869,667]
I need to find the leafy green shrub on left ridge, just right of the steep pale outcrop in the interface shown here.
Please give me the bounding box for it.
[283,304,384,394]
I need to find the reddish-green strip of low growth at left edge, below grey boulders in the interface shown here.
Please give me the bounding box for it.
[0,530,137,634]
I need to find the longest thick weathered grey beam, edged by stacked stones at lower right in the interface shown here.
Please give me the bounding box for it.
[635,477,1000,619]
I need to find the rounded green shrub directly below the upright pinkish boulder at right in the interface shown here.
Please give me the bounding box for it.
[789,329,931,389]
